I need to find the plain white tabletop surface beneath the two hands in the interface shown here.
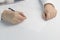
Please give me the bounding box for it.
[0,0,60,40]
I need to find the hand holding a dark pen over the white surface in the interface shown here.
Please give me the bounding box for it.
[1,10,26,24]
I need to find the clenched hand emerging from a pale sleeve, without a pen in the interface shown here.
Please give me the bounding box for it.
[42,3,57,20]
